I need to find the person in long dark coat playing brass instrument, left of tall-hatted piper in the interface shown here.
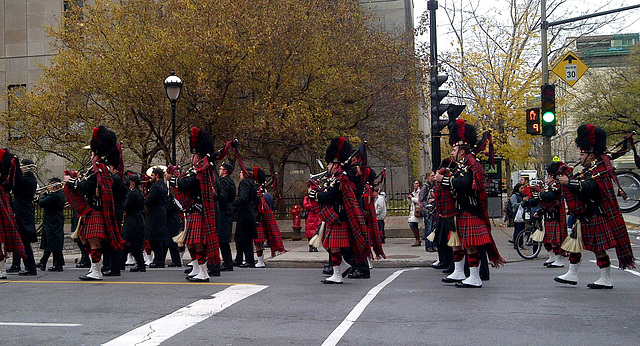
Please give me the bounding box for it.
[38,178,66,272]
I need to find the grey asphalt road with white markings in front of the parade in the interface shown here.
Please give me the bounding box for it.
[0,248,640,345]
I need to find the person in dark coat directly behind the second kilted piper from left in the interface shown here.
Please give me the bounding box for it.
[122,174,146,272]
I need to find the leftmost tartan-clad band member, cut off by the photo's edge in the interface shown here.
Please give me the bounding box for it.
[0,149,26,279]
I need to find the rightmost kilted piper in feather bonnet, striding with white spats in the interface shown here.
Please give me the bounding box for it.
[554,124,635,289]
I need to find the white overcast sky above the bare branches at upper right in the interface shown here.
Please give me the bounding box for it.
[413,0,640,49]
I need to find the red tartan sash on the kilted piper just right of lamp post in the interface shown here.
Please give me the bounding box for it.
[195,157,220,264]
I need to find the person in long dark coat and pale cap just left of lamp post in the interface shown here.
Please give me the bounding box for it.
[144,168,170,268]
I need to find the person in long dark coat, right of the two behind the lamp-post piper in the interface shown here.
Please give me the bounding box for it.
[233,170,258,268]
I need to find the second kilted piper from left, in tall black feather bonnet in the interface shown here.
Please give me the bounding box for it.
[64,126,123,280]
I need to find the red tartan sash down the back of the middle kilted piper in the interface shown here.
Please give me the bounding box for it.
[339,173,371,261]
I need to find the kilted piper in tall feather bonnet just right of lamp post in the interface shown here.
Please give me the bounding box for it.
[170,126,220,282]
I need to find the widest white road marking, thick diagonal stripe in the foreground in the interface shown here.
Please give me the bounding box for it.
[104,285,268,345]
